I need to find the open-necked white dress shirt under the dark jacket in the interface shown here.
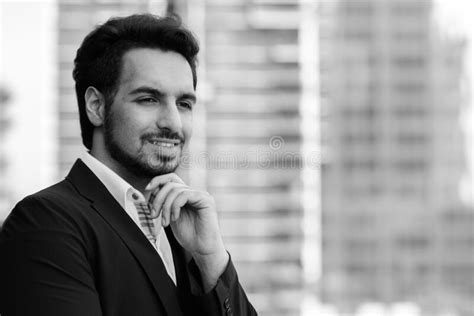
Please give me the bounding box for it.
[81,152,176,284]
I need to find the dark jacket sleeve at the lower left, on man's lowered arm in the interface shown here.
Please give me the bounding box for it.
[0,198,102,316]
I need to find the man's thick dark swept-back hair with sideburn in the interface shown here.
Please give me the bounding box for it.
[73,14,199,149]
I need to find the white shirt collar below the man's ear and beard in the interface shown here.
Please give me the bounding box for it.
[81,152,145,209]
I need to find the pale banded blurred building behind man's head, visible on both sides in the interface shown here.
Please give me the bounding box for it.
[58,0,310,316]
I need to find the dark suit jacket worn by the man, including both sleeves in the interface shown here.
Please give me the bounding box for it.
[0,160,256,316]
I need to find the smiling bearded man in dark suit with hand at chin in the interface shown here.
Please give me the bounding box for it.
[0,14,256,316]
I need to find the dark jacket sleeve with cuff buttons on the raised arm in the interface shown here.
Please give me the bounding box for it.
[185,254,257,316]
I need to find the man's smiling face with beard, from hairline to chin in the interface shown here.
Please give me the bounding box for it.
[104,48,196,178]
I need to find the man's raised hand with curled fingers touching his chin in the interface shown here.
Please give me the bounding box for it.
[146,173,229,291]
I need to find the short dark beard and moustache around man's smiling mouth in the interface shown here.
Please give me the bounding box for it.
[104,107,184,178]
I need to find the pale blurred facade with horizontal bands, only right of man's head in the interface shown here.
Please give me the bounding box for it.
[201,0,306,316]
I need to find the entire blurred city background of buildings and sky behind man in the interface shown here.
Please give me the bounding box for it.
[0,0,474,316]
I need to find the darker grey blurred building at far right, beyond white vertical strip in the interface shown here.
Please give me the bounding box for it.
[320,0,474,315]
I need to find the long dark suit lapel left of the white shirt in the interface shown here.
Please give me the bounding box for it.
[66,160,181,315]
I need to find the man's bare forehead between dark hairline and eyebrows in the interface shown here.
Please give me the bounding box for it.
[119,48,194,92]
